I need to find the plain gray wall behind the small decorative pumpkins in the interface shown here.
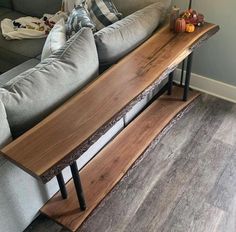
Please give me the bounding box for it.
[173,0,236,86]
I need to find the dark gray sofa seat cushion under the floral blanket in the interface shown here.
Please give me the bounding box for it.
[0,11,45,73]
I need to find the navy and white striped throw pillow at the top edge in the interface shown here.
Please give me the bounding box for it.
[85,0,122,30]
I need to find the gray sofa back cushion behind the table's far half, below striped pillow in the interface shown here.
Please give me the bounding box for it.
[94,3,162,65]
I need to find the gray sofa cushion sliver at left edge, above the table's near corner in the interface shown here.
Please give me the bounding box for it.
[0,101,12,149]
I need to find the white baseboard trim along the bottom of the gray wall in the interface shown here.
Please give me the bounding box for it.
[174,69,236,103]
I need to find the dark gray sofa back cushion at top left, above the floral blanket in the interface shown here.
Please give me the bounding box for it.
[12,0,62,18]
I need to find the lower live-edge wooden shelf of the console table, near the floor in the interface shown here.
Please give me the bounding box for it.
[41,87,199,231]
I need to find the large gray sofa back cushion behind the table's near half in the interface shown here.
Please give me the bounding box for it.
[0,28,99,137]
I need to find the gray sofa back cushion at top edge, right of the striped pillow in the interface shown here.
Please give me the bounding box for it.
[113,0,171,16]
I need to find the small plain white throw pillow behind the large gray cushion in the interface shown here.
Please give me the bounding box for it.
[41,19,66,60]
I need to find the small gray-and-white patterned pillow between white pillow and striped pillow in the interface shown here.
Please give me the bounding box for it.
[66,5,95,38]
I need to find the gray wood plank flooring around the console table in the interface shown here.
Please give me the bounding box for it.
[25,95,236,232]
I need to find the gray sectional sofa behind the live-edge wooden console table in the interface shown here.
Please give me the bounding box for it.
[0,0,170,232]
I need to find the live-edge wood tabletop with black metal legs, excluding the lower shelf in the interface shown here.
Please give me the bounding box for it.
[1,23,219,230]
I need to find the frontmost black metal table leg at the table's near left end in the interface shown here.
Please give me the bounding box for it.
[70,162,86,211]
